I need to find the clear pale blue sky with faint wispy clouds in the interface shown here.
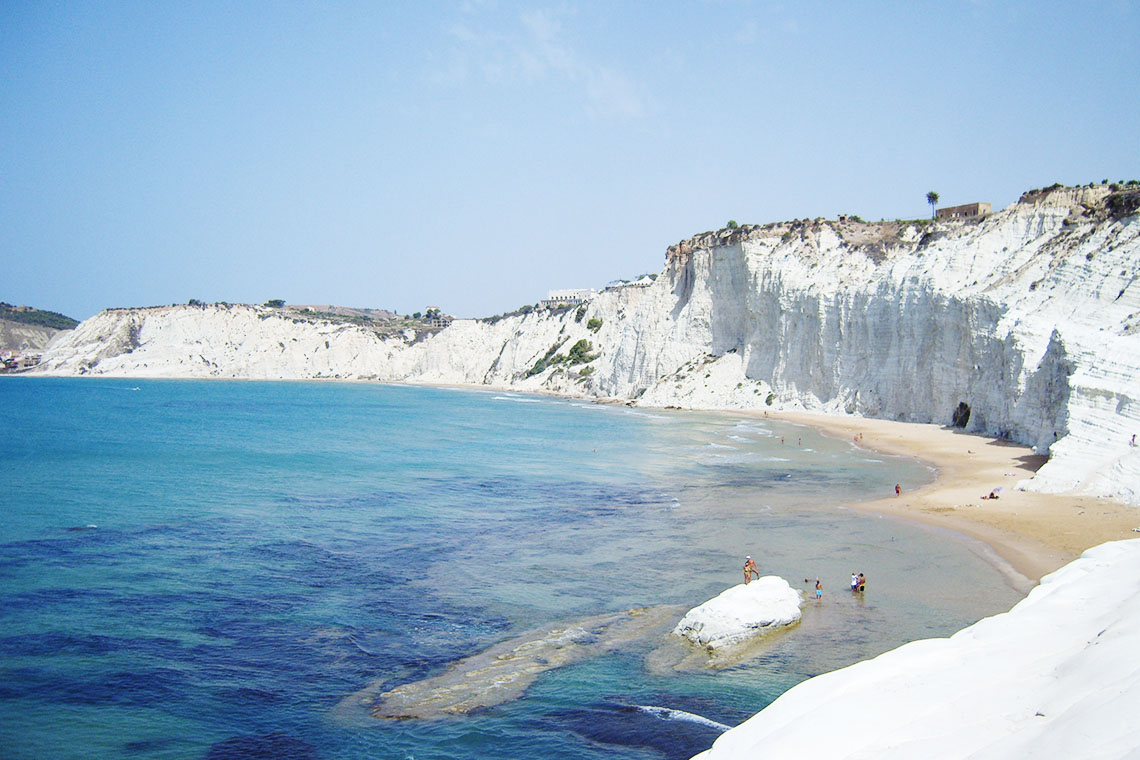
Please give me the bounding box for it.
[0,0,1140,319]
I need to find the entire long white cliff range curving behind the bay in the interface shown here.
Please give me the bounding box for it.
[33,187,1140,504]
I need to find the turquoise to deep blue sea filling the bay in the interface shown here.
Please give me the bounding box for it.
[0,378,1018,760]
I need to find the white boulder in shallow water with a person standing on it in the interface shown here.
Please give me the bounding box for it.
[673,575,803,649]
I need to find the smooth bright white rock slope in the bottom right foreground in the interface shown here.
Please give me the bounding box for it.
[697,540,1140,760]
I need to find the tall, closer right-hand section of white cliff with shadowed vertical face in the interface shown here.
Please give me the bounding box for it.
[624,188,1140,502]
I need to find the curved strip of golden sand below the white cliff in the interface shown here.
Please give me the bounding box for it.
[759,411,1140,582]
